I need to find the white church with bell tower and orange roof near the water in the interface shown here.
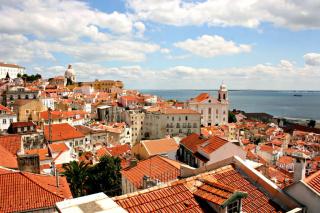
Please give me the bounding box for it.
[186,84,229,126]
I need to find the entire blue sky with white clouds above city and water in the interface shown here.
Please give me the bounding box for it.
[0,0,320,90]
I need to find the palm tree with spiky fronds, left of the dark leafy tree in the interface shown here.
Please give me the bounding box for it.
[62,161,89,197]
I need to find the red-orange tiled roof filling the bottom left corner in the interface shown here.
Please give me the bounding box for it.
[0,172,72,212]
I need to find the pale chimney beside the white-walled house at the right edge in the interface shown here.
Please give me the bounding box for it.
[293,153,309,183]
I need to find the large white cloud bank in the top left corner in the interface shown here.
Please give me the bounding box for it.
[0,0,132,39]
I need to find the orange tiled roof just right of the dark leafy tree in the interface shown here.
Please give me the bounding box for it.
[121,155,180,188]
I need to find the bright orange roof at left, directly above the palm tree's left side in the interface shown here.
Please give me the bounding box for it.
[44,123,84,142]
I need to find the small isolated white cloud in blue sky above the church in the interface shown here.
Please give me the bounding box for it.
[174,35,251,58]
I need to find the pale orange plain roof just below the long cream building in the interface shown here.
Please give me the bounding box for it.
[141,138,179,156]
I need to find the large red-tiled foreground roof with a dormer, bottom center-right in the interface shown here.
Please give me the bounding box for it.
[113,165,282,212]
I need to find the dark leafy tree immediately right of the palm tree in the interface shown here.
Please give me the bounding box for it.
[89,156,121,196]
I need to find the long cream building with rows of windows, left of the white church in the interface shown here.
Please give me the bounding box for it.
[143,108,200,139]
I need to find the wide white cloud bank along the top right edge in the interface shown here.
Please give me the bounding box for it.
[127,0,320,30]
